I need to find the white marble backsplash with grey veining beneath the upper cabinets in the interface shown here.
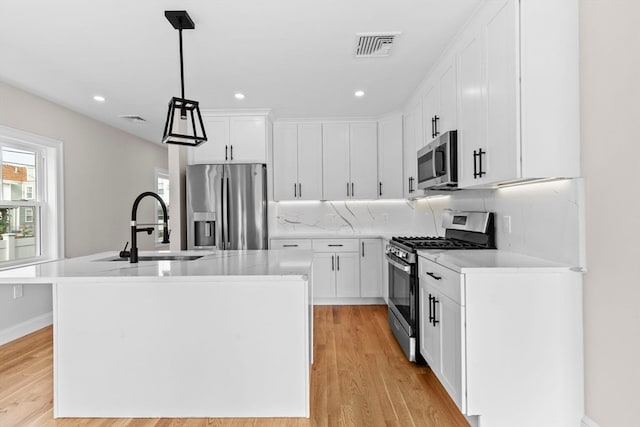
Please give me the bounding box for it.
[269,179,585,267]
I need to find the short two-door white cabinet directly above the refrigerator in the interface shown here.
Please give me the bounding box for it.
[189,111,267,164]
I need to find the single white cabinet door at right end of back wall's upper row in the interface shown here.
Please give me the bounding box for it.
[378,114,403,199]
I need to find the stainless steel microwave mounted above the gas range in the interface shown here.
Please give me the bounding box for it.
[418,130,458,190]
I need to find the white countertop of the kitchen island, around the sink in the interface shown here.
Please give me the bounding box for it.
[0,250,313,283]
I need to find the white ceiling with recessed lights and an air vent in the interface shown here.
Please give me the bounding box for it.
[0,0,481,143]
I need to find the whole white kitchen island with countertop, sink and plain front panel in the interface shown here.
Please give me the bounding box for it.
[0,251,312,418]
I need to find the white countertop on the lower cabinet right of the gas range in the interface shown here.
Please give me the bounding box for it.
[418,249,581,273]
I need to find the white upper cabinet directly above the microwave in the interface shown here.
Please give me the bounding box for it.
[418,61,457,148]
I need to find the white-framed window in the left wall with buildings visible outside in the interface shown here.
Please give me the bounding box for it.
[0,126,64,268]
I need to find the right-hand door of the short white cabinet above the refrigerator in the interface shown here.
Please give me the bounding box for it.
[229,116,267,163]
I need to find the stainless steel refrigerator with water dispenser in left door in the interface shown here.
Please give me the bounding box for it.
[187,163,268,249]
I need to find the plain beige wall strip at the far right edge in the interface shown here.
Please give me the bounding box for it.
[580,0,640,427]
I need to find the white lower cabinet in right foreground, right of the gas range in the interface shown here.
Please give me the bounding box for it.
[418,256,584,427]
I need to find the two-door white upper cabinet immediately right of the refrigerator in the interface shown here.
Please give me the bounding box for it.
[273,122,322,200]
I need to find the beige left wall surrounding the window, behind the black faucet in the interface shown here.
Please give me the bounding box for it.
[0,83,167,257]
